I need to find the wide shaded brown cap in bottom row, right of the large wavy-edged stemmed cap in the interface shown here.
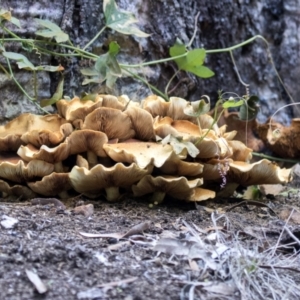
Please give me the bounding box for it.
[132,175,203,200]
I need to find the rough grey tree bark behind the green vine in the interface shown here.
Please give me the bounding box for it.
[0,0,300,123]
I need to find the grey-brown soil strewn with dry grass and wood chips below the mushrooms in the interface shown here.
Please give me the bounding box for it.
[0,177,300,300]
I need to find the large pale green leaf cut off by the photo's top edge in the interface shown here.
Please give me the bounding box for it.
[103,0,149,37]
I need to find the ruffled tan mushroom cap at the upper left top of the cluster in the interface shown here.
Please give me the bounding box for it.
[56,95,102,122]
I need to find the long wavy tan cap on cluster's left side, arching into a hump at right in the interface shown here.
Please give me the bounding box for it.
[17,129,108,163]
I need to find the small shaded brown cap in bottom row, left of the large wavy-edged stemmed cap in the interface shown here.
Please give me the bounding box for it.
[27,172,72,196]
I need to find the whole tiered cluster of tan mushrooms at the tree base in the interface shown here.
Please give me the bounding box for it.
[0,95,290,203]
